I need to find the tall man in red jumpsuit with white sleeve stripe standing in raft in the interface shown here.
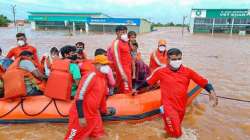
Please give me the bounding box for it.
[111,26,132,93]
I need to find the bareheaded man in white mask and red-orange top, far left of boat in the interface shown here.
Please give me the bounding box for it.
[6,33,39,64]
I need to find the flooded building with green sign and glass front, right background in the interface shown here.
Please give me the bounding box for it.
[189,9,250,34]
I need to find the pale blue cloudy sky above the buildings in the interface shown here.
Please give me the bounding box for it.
[0,0,250,23]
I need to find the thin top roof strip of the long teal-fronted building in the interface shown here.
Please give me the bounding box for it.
[28,12,102,15]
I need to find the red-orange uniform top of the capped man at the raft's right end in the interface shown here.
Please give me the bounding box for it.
[149,49,168,72]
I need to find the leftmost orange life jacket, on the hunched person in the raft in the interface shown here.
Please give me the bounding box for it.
[2,57,45,98]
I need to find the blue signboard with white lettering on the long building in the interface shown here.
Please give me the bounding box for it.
[89,18,140,26]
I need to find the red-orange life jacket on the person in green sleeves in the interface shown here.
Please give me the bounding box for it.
[44,59,73,100]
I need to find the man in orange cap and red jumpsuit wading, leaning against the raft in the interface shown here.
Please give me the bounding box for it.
[65,55,115,140]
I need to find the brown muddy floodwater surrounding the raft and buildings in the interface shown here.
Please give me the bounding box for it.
[0,25,250,140]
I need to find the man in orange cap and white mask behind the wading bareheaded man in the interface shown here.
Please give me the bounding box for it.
[149,39,168,72]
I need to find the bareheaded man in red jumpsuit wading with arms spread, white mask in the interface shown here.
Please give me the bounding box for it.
[135,48,218,138]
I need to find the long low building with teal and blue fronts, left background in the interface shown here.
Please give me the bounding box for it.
[28,12,151,33]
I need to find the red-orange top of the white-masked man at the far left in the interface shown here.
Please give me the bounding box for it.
[6,44,39,64]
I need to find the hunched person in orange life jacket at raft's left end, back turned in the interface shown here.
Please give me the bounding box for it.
[3,51,47,97]
